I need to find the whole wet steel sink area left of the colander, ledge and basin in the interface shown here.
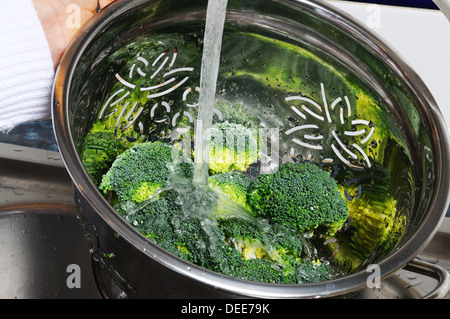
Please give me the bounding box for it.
[0,143,99,299]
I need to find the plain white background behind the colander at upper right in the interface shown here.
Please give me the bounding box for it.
[327,0,450,129]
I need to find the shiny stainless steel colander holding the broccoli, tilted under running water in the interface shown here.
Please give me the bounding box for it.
[53,0,450,298]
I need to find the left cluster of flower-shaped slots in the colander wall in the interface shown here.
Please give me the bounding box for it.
[99,47,222,133]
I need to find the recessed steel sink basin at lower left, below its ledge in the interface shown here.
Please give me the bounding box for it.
[0,205,98,299]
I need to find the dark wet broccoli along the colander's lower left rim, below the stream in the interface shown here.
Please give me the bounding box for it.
[114,189,223,269]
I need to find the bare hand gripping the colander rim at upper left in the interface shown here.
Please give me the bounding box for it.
[33,0,114,69]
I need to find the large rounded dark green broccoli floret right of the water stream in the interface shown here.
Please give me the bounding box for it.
[248,163,348,235]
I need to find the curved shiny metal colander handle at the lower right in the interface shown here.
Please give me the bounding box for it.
[404,258,450,299]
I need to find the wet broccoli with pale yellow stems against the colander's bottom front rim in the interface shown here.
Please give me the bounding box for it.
[219,217,335,283]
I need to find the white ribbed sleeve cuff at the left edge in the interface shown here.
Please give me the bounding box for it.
[0,0,55,131]
